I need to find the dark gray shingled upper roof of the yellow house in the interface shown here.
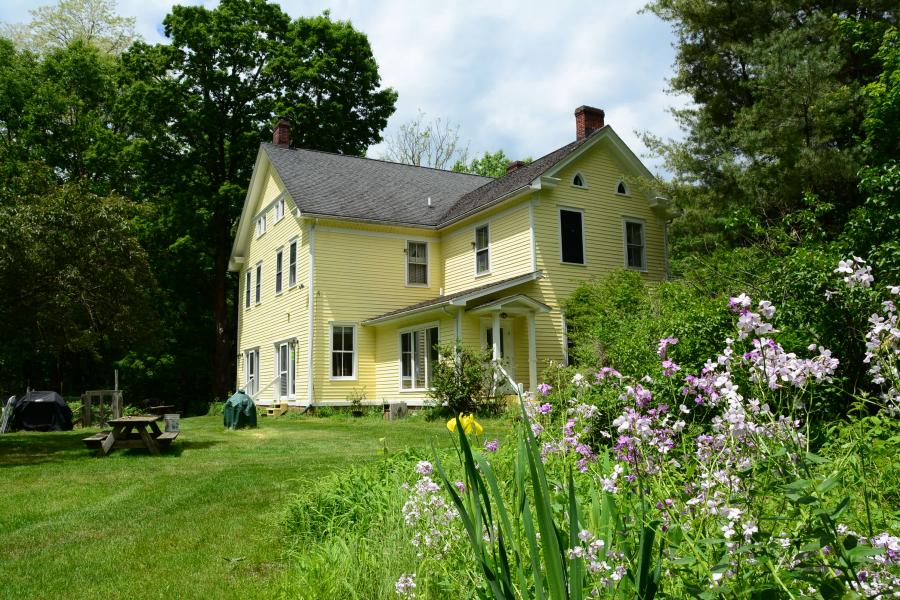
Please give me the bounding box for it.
[262,130,601,227]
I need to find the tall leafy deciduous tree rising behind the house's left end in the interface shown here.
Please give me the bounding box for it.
[123,0,396,398]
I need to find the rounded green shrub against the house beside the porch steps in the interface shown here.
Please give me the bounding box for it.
[428,343,494,415]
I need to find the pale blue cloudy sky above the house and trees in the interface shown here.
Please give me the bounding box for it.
[0,0,686,177]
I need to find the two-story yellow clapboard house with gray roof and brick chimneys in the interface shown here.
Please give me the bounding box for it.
[229,106,668,406]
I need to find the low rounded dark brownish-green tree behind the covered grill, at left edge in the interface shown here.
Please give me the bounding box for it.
[0,173,154,391]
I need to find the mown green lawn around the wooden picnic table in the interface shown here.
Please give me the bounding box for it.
[0,416,468,599]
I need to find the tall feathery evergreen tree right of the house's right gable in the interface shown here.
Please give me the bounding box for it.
[648,0,898,255]
